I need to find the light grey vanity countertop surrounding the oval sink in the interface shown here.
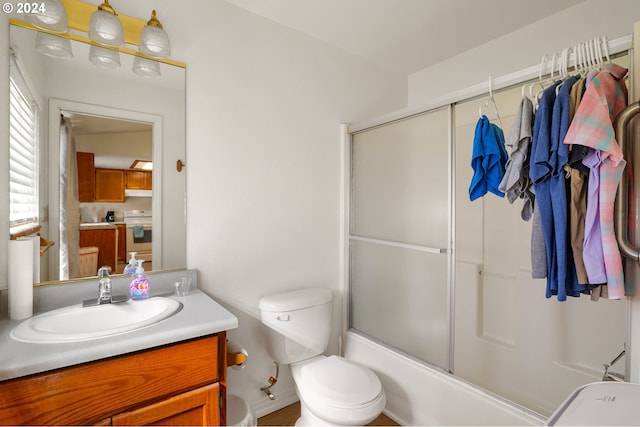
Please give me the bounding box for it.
[0,270,238,381]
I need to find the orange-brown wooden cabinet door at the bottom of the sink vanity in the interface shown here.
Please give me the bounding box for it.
[111,384,220,426]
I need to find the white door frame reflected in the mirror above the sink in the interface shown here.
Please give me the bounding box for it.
[49,98,164,283]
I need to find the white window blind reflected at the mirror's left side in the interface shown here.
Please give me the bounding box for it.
[9,67,38,227]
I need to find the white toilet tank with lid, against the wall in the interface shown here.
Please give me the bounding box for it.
[259,288,333,364]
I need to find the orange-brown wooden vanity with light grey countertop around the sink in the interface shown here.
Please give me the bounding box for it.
[0,271,238,425]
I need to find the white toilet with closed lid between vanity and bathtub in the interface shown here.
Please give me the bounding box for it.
[259,288,387,426]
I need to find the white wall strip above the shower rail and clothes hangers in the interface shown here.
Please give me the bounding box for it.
[409,0,640,106]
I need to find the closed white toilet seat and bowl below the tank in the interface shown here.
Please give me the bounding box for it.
[291,356,386,424]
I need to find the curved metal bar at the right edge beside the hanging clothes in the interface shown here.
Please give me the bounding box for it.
[614,101,640,264]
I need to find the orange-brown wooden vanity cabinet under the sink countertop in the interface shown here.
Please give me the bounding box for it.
[0,332,226,426]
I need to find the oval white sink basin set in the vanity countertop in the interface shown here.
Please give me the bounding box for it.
[11,297,182,343]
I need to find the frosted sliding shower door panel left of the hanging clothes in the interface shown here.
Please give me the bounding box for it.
[349,107,452,370]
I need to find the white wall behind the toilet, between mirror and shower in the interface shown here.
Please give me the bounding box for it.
[181,1,406,415]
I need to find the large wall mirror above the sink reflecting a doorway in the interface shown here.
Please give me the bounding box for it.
[10,22,186,282]
